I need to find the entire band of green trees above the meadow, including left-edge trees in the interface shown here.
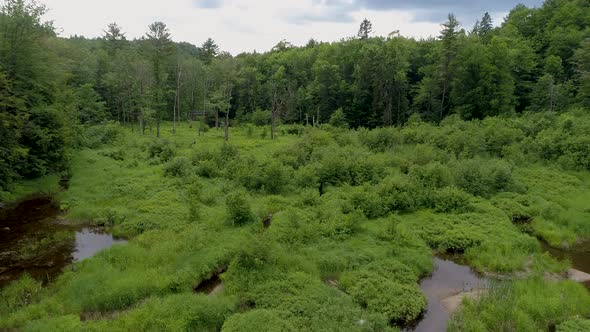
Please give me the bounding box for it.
[0,0,590,188]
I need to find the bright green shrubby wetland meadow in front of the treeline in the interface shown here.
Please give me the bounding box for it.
[0,109,590,331]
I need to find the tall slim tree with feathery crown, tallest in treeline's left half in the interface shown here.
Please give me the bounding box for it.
[146,22,174,137]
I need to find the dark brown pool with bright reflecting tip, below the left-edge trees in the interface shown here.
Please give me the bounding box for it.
[0,197,125,287]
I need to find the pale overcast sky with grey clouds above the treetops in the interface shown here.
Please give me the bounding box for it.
[39,0,542,54]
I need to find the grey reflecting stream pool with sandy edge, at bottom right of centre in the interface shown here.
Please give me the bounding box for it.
[408,257,488,332]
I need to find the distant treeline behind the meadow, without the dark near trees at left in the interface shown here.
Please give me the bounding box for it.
[55,0,590,128]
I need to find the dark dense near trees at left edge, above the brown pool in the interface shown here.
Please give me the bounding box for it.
[0,0,70,189]
